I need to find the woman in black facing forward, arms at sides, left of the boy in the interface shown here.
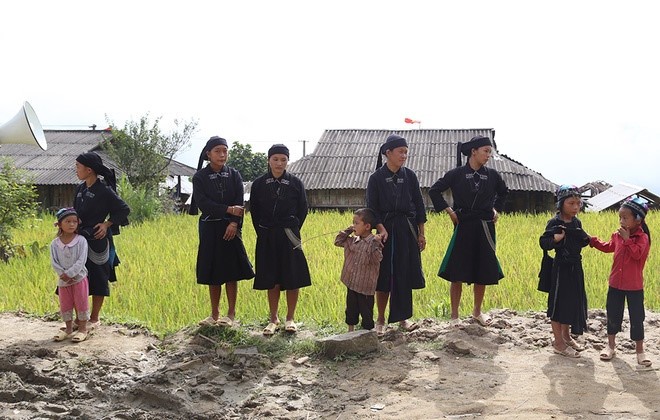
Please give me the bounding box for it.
[250,144,312,335]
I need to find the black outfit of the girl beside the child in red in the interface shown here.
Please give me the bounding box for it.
[539,215,589,334]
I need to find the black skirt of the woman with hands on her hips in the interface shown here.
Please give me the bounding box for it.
[438,220,504,285]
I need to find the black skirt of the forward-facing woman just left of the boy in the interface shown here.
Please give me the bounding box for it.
[253,227,312,290]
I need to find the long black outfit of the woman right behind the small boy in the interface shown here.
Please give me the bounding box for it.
[367,165,426,322]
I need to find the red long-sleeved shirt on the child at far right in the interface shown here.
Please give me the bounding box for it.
[589,228,650,290]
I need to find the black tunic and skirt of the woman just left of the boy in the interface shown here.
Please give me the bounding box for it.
[250,171,312,290]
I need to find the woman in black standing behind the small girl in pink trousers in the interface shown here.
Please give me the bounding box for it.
[73,152,131,331]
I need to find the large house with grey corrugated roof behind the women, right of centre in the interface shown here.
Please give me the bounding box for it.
[288,129,557,212]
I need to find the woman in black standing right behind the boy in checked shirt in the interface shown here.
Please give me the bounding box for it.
[367,134,426,335]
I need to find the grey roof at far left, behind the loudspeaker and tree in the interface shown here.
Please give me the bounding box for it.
[0,130,195,185]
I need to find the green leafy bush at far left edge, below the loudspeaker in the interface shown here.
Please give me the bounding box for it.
[0,159,37,262]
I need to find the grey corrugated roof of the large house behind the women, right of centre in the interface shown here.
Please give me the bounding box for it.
[288,128,557,193]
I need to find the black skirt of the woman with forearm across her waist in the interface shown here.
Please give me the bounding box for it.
[196,219,254,286]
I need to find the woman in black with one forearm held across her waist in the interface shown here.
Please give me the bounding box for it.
[190,136,254,327]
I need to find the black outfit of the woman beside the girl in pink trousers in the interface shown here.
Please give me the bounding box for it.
[73,179,131,296]
